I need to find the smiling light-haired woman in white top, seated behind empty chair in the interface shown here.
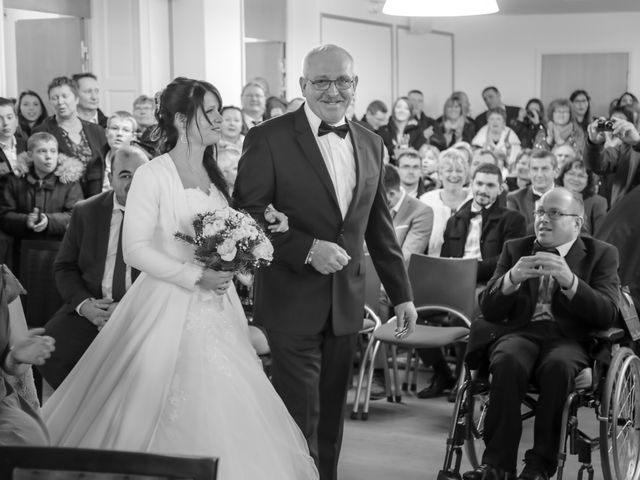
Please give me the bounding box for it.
[420,148,471,257]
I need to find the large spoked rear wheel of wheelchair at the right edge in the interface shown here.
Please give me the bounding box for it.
[600,348,640,480]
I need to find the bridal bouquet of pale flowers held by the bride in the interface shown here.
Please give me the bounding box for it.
[175,207,273,273]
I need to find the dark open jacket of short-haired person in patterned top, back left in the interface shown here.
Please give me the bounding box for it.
[33,115,107,198]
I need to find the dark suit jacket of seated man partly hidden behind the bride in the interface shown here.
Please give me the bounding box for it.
[53,190,113,316]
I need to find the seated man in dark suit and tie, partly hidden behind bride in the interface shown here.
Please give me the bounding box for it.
[39,146,147,388]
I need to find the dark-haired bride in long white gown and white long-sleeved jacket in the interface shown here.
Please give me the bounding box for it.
[43,78,318,480]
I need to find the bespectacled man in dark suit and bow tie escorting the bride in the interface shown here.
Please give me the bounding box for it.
[234,45,417,480]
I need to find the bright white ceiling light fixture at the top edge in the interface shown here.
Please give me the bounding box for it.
[382,0,499,17]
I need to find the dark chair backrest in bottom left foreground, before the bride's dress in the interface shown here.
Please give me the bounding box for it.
[0,447,218,480]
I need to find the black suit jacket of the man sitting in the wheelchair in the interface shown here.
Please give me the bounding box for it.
[467,236,620,368]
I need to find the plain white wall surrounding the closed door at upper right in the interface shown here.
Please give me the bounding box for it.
[433,13,640,114]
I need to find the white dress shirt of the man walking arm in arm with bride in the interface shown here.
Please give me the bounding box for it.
[304,103,356,218]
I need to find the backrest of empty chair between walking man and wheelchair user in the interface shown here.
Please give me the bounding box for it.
[409,253,478,320]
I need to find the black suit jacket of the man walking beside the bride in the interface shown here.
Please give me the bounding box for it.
[234,106,412,335]
